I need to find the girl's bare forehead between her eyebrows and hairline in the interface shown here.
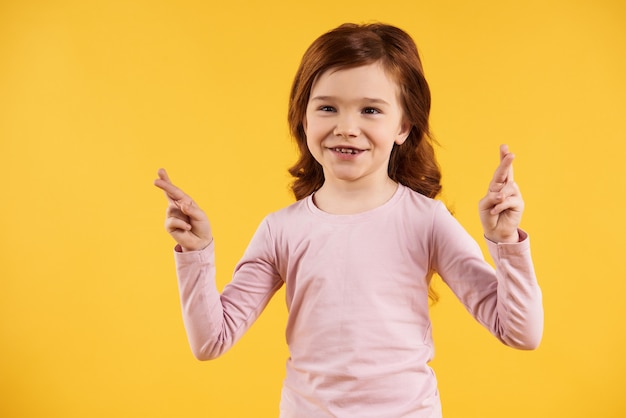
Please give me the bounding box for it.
[311,62,399,99]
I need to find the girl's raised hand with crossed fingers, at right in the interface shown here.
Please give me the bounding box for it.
[478,145,524,243]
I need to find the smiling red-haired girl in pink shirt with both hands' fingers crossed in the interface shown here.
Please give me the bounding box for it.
[155,24,543,418]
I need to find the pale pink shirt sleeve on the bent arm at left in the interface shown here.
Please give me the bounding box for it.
[175,220,283,360]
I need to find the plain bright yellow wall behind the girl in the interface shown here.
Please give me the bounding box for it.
[0,0,626,418]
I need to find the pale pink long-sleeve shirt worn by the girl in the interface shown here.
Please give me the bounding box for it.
[175,185,543,418]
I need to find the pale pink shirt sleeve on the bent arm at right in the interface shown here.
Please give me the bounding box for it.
[432,204,543,350]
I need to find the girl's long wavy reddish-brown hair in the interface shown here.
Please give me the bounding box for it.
[288,23,441,200]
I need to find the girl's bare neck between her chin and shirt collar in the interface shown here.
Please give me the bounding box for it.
[313,177,398,215]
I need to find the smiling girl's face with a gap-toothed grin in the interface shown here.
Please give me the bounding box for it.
[304,63,410,189]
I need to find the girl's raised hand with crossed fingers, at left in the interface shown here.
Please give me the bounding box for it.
[154,169,213,252]
